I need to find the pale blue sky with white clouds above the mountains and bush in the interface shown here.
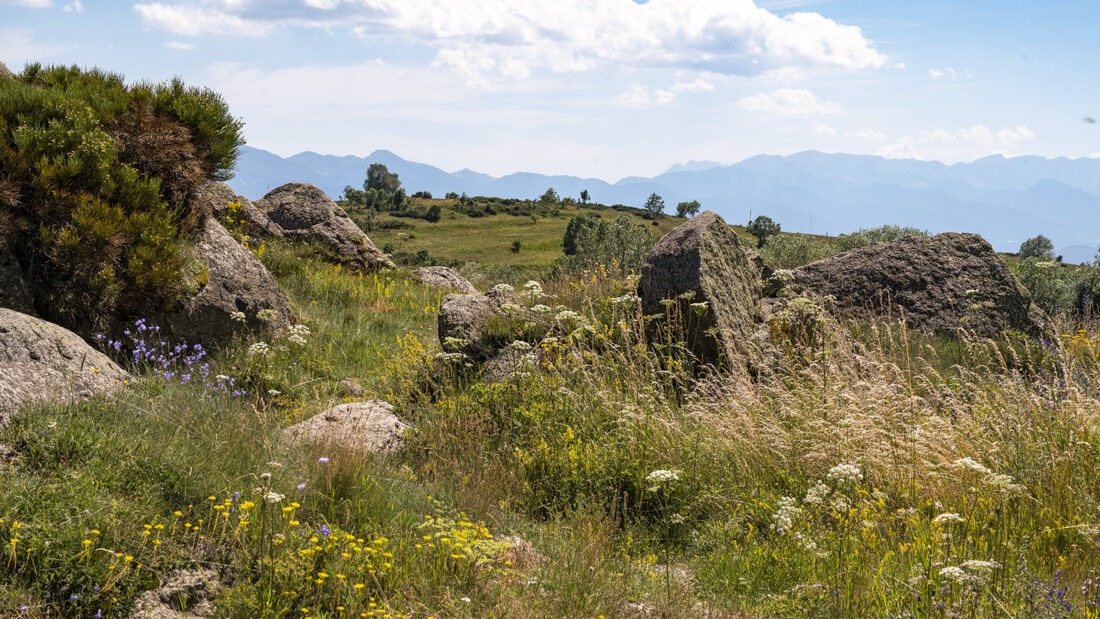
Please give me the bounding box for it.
[0,0,1100,181]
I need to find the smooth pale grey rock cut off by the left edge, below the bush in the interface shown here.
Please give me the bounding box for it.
[0,308,130,420]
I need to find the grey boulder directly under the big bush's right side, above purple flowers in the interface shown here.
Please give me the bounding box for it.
[167,218,292,345]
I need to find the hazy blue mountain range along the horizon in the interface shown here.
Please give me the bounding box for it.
[230,146,1100,263]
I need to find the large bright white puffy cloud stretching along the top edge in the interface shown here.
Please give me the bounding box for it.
[134,0,887,81]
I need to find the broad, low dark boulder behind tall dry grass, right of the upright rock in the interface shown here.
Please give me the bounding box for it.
[788,233,1051,336]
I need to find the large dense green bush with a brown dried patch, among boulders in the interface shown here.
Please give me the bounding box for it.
[0,65,243,333]
